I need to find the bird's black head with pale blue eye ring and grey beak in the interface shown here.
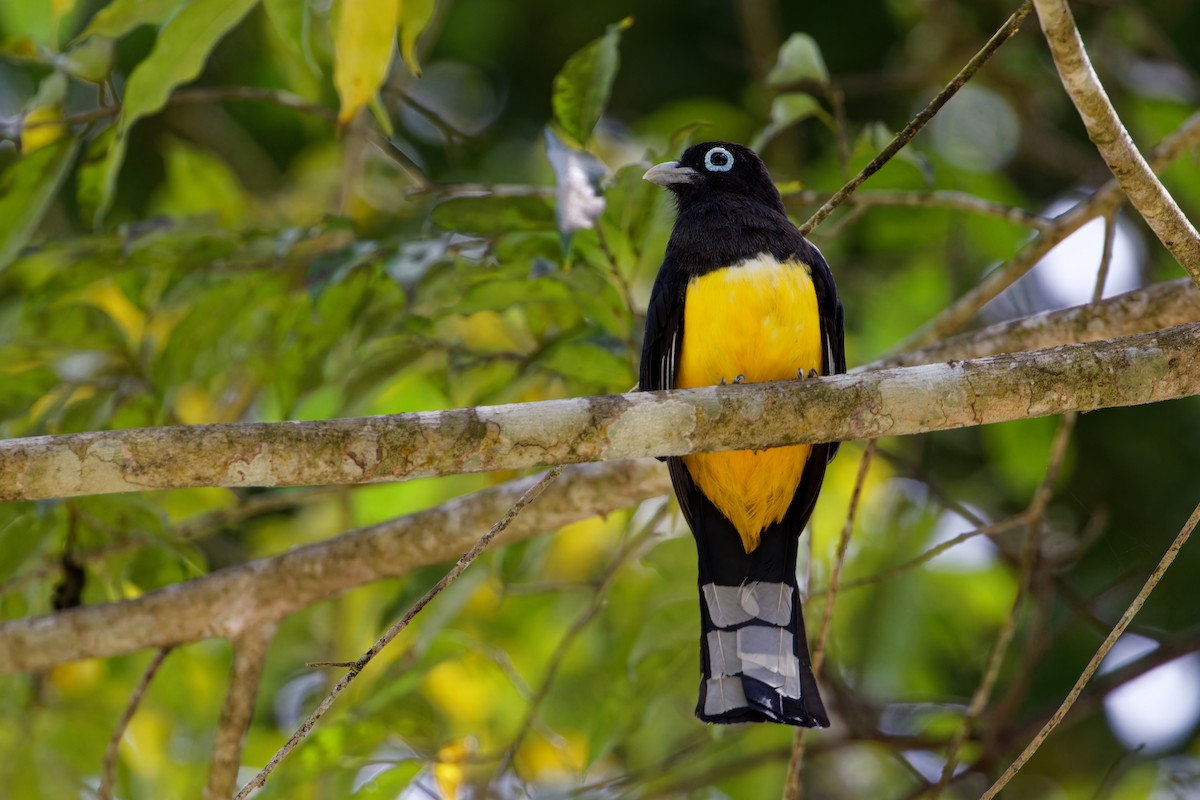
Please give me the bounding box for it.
[644,142,784,212]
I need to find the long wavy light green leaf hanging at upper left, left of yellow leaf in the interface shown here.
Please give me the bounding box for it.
[96,0,258,224]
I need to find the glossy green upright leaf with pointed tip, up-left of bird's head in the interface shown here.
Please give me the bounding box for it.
[551,17,634,148]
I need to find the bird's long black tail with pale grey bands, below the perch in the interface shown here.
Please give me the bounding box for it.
[671,452,829,728]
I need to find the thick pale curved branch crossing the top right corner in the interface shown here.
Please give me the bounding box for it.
[1033,0,1200,285]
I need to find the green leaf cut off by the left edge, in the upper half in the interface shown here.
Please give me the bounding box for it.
[0,138,79,270]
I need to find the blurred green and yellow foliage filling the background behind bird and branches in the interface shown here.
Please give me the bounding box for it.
[0,0,1200,799]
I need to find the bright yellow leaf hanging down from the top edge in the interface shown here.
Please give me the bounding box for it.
[334,0,400,126]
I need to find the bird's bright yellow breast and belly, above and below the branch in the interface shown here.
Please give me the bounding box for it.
[676,255,822,553]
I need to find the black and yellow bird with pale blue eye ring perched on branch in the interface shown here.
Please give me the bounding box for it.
[638,142,846,728]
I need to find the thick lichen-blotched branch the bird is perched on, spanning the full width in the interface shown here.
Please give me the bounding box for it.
[0,325,1200,500]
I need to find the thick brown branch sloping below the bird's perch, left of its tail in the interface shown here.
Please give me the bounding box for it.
[0,461,671,674]
